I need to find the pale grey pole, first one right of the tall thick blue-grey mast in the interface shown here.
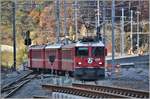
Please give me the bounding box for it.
[121,8,125,56]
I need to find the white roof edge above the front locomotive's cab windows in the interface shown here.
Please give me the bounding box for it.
[75,41,104,47]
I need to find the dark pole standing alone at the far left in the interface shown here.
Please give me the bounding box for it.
[12,2,16,71]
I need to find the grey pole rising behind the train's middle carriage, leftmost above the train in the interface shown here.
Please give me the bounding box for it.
[55,0,60,43]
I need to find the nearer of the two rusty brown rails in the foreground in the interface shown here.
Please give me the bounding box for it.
[42,84,127,98]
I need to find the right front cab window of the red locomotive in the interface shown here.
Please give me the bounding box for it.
[92,47,104,57]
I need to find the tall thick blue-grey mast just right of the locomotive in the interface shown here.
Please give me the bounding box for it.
[111,0,115,72]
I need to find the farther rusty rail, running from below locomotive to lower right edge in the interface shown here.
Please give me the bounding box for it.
[72,83,149,98]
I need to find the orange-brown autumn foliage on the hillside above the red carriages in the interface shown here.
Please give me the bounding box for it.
[30,1,73,44]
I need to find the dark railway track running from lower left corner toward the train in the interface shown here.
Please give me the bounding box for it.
[1,72,37,98]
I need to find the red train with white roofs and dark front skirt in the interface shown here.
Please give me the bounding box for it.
[28,38,107,81]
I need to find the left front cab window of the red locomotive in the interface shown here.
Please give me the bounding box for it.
[76,47,88,57]
